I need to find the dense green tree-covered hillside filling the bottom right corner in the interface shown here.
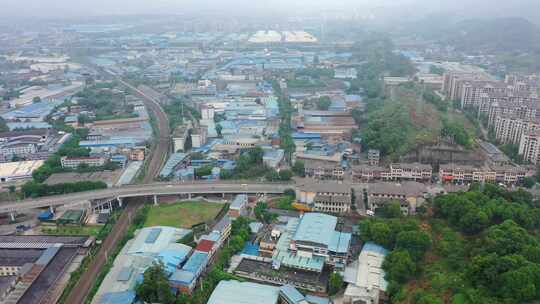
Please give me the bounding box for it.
[361,184,540,304]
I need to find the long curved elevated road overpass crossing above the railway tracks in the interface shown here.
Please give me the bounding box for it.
[0,182,294,213]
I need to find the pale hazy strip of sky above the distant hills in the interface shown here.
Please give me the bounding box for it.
[0,0,540,21]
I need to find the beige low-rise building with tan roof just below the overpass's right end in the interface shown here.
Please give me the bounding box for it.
[296,179,352,213]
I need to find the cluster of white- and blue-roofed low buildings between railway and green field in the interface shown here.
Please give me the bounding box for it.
[92,216,231,304]
